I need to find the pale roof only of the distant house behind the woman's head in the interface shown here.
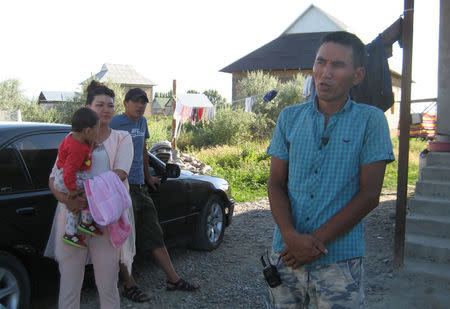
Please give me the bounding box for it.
[83,63,156,86]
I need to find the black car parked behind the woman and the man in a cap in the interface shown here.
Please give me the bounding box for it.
[0,122,234,308]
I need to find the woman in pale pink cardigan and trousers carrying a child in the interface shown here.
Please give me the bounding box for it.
[44,81,136,309]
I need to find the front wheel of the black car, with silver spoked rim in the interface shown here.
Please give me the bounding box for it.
[193,195,225,251]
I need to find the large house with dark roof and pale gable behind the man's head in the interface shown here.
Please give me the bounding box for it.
[220,5,401,100]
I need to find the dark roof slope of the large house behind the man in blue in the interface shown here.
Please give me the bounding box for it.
[220,32,328,73]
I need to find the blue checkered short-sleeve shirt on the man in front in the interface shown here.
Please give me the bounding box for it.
[267,99,394,264]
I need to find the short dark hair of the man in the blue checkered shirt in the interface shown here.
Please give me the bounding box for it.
[319,31,367,68]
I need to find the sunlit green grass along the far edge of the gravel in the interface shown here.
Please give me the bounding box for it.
[189,137,426,202]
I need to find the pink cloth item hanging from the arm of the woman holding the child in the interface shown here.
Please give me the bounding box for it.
[84,171,131,248]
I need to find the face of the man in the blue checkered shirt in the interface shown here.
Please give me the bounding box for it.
[313,42,365,103]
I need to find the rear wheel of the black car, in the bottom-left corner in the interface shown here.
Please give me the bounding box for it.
[0,252,31,309]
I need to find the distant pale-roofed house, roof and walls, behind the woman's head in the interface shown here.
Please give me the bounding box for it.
[81,63,156,116]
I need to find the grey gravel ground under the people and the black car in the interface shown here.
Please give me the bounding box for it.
[33,192,396,309]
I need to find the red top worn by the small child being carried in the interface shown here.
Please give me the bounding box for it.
[56,134,92,190]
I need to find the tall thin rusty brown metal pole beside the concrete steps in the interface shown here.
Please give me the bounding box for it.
[394,0,414,267]
